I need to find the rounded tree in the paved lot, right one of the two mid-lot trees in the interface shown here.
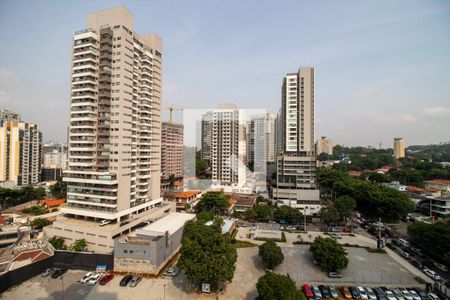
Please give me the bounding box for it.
[309,236,348,272]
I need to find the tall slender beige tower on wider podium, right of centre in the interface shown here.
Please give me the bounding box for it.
[273,67,320,214]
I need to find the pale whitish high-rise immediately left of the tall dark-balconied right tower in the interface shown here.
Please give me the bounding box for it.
[247,113,276,170]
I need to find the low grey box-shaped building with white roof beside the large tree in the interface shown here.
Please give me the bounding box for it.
[114,213,195,275]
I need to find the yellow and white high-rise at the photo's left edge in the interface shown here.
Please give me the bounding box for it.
[0,118,42,185]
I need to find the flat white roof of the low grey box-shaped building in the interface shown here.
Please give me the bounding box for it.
[136,212,195,236]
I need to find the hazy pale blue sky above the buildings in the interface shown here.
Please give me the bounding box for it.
[0,0,450,147]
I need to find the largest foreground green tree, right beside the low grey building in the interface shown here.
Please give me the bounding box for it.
[178,220,237,290]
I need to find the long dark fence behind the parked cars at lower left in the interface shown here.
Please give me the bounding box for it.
[0,251,114,293]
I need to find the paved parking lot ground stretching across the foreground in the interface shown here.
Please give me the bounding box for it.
[0,245,418,300]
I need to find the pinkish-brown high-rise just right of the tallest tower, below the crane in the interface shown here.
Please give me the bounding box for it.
[161,122,184,181]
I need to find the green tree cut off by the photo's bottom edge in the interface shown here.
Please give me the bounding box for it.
[256,272,302,300]
